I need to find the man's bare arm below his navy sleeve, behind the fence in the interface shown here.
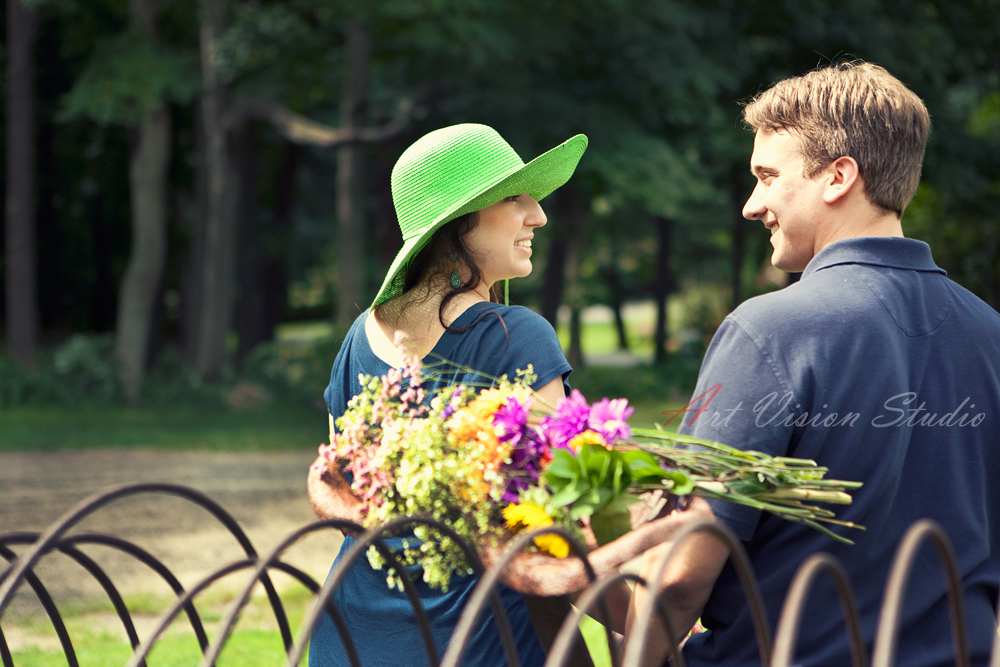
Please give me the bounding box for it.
[626,498,729,667]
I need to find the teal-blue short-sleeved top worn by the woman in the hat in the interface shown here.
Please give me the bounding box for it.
[309,302,572,667]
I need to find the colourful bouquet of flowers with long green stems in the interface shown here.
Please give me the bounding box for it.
[320,356,861,588]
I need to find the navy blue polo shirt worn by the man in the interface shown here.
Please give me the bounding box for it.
[681,238,1000,667]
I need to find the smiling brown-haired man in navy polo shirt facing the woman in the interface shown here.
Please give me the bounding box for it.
[631,63,1000,667]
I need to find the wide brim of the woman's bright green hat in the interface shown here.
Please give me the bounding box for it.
[371,134,587,310]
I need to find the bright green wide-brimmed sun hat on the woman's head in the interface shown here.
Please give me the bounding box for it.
[371,123,587,309]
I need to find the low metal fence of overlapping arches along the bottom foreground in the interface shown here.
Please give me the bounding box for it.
[0,484,1000,667]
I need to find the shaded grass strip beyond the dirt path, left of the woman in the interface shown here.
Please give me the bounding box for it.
[0,405,327,452]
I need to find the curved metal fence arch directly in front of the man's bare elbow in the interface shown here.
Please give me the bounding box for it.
[625,519,771,667]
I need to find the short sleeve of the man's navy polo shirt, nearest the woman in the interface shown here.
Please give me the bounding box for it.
[678,316,795,541]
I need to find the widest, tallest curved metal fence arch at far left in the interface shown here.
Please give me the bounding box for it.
[0,483,292,656]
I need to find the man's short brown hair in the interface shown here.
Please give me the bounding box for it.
[743,61,931,215]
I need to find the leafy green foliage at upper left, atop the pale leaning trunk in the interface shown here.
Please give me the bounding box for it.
[59,30,201,125]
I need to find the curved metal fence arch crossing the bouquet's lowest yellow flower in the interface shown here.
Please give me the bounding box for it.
[441,526,592,667]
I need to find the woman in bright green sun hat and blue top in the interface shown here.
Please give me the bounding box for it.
[309,124,587,667]
